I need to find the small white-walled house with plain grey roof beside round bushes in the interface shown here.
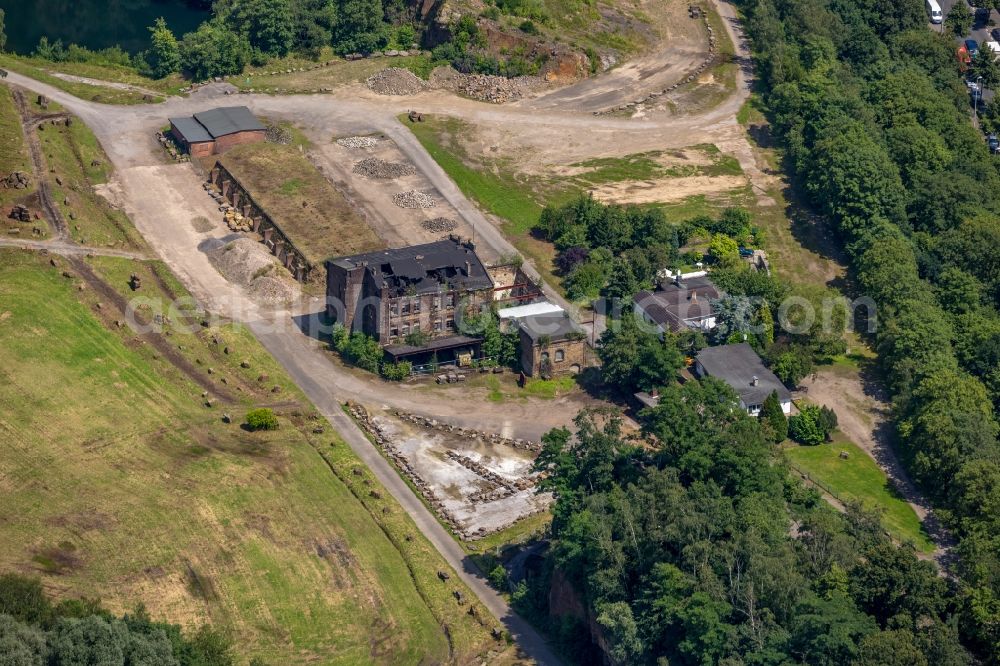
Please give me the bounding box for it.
[694,342,792,416]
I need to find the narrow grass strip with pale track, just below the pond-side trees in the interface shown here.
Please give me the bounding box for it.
[0,53,180,105]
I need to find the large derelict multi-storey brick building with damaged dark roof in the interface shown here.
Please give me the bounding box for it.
[326,236,494,361]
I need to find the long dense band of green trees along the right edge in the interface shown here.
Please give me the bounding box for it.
[740,0,1000,663]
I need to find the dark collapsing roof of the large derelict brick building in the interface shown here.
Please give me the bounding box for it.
[327,238,493,295]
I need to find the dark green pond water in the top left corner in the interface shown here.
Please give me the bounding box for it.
[0,0,210,54]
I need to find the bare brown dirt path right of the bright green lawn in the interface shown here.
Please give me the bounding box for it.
[802,369,954,570]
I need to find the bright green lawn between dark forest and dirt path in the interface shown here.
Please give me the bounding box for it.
[785,437,934,553]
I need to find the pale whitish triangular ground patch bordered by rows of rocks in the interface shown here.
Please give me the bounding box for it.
[373,413,552,533]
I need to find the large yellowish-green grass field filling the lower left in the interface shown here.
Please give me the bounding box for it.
[0,250,502,664]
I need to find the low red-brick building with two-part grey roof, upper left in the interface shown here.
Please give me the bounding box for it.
[170,106,267,157]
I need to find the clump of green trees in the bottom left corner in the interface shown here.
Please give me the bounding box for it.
[0,574,237,666]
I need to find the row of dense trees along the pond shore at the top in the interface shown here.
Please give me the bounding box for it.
[15,0,546,81]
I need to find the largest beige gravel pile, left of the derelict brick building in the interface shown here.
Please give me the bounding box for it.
[207,238,296,305]
